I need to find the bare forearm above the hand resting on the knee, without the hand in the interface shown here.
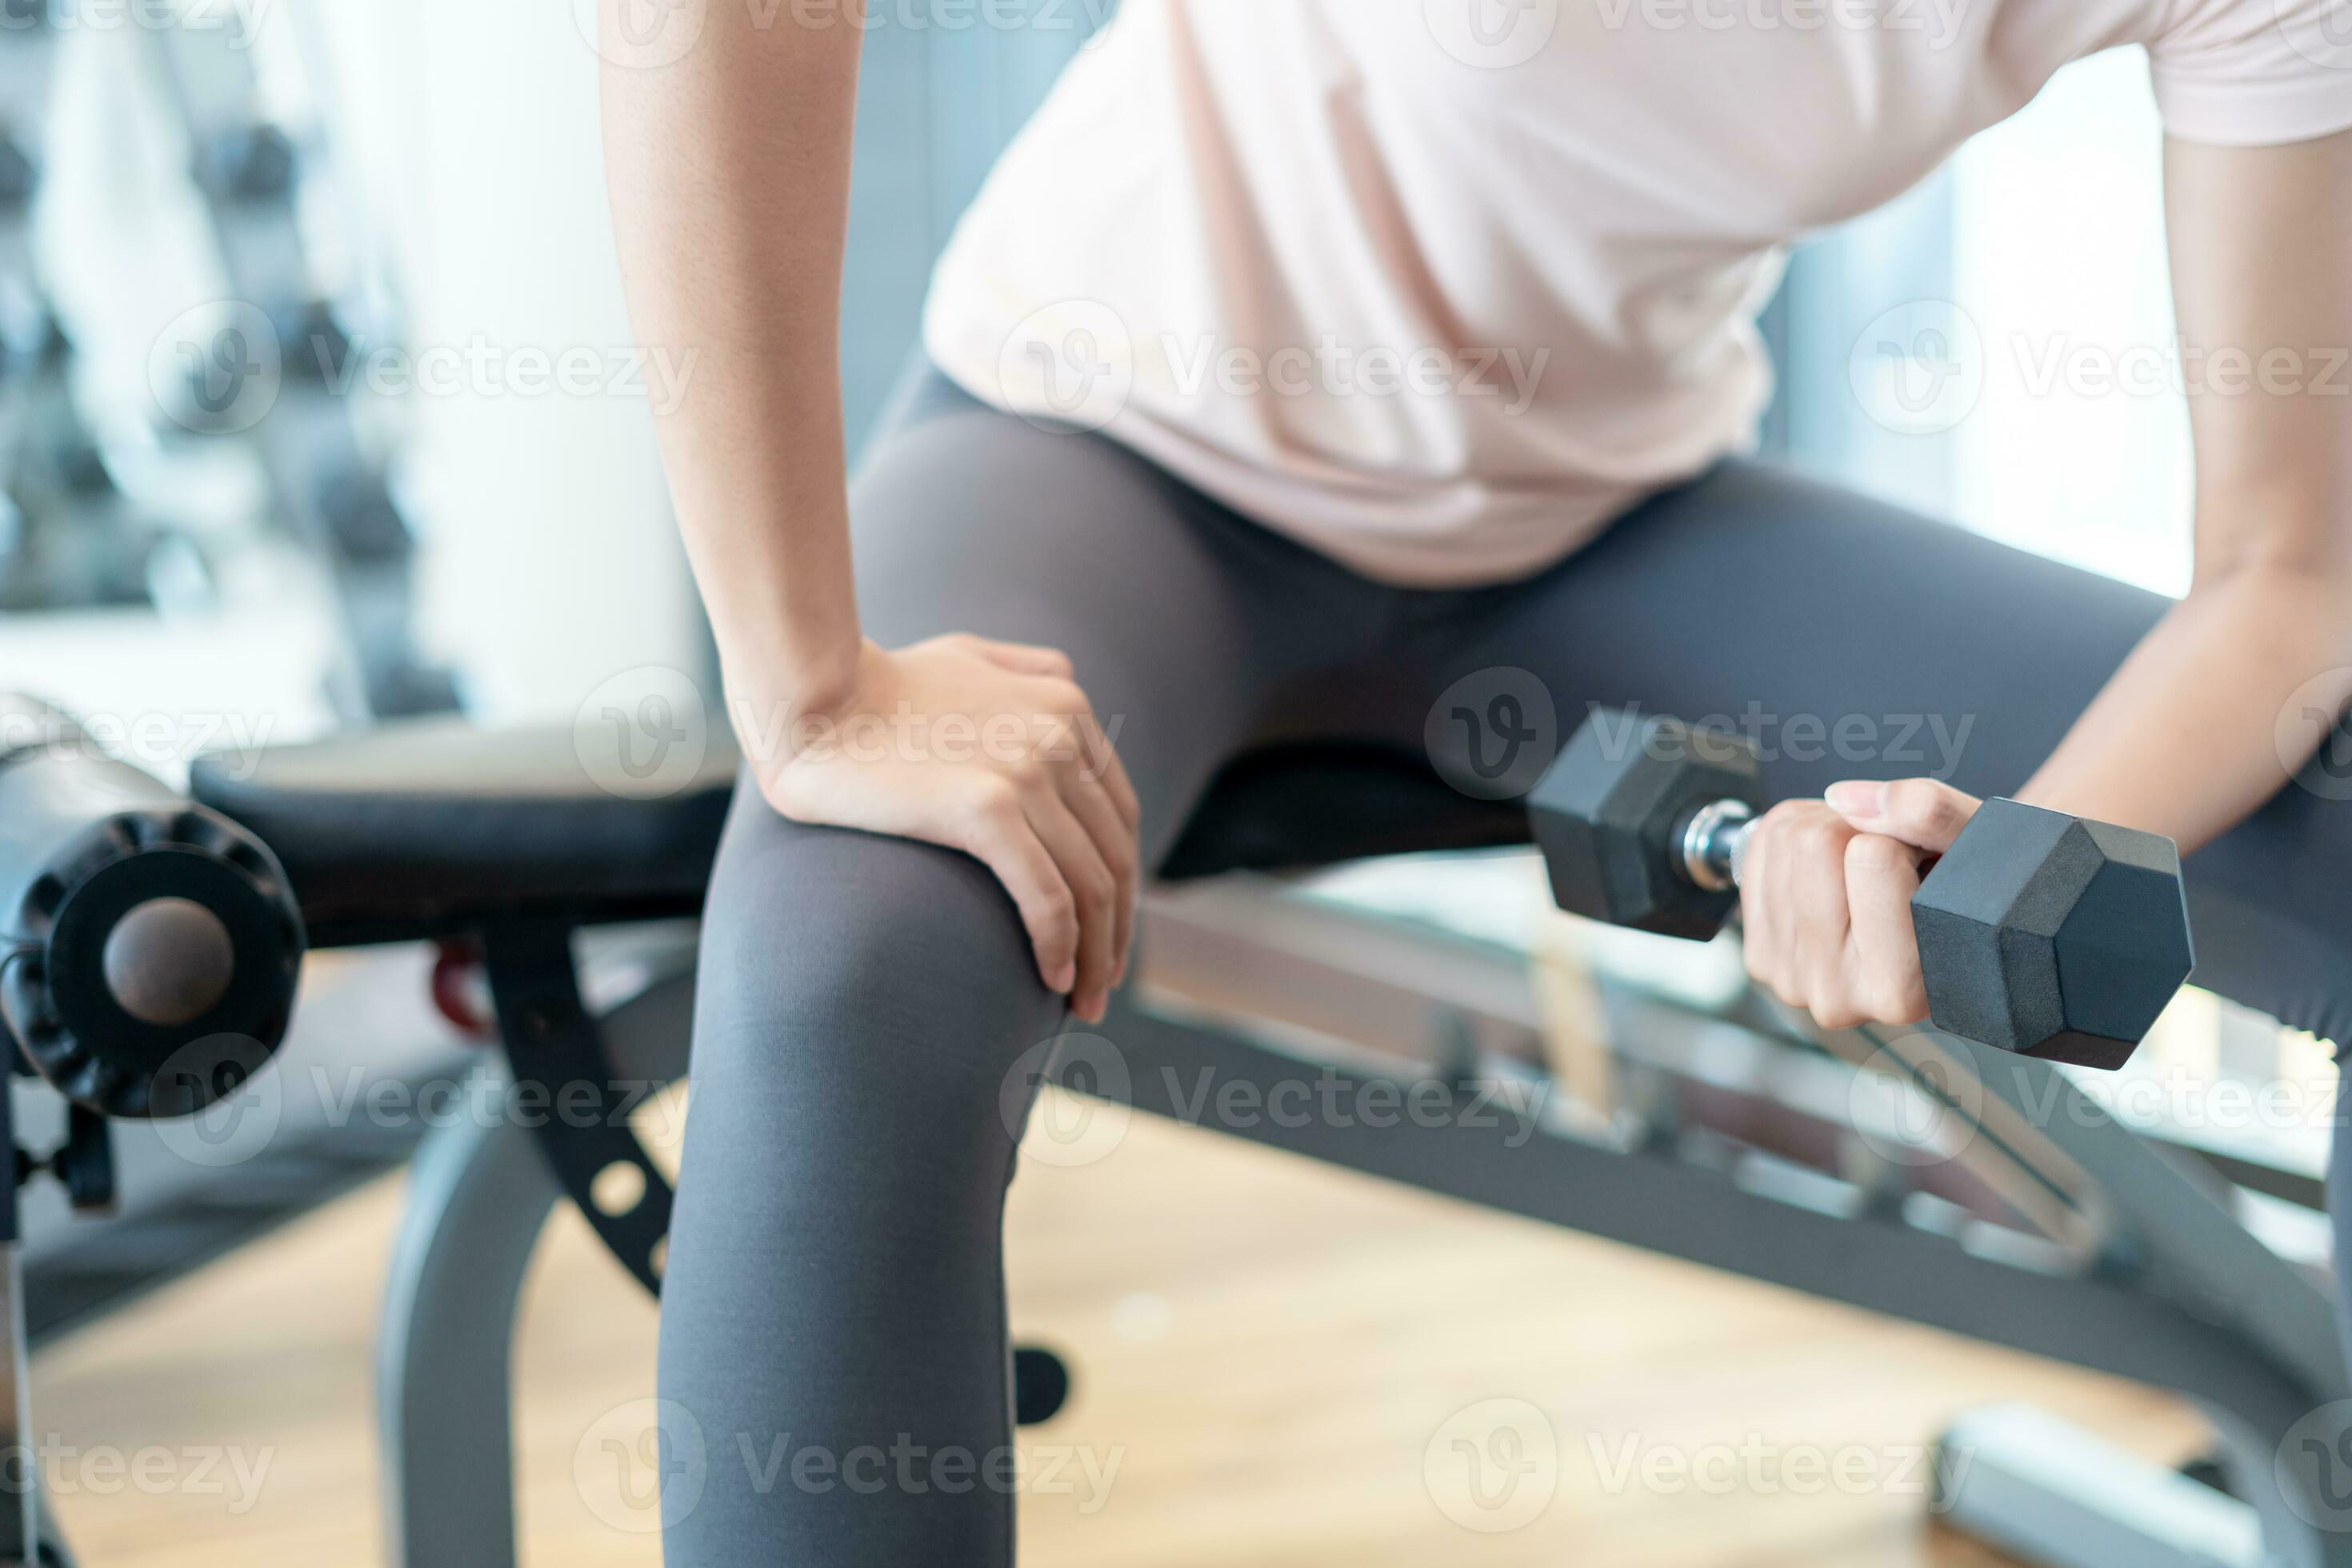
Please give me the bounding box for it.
[605,5,863,703]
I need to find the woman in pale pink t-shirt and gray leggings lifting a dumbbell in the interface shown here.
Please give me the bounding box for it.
[592,0,2352,1568]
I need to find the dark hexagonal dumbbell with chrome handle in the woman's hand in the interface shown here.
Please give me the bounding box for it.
[1526,710,2192,1067]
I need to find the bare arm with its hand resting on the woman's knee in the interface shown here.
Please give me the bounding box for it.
[600,0,1138,1018]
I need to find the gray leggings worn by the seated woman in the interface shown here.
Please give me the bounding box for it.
[661,376,2164,1568]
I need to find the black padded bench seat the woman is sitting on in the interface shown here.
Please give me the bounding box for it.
[190,719,1526,945]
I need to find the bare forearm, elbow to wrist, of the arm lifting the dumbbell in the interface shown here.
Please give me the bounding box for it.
[2018,564,2352,851]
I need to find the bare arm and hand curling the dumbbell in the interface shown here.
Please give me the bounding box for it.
[1741,132,2352,1025]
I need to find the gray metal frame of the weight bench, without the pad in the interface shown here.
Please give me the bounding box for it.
[378,879,2352,1568]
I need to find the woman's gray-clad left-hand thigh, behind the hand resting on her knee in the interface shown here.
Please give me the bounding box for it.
[851,383,1397,865]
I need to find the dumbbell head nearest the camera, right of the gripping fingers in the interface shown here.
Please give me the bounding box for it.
[1912,799,2194,1067]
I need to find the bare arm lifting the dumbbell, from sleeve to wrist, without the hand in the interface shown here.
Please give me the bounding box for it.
[2022,132,2352,849]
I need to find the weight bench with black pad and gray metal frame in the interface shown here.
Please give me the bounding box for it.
[0,700,2352,1568]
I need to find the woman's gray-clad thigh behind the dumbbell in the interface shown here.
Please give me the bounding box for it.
[1442,463,2169,794]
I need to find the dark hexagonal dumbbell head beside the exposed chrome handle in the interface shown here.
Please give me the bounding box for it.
[1526,707,1764,938]
